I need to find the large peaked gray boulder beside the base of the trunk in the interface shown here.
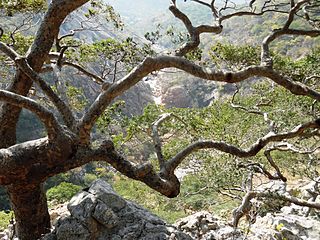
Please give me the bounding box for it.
[42,180,192,240]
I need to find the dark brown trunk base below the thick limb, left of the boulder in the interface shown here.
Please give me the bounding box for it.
[7,183,50,240]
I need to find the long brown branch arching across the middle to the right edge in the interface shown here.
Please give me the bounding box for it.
[79,56,320,142]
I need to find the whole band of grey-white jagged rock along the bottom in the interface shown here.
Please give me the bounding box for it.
[0,180,320,240]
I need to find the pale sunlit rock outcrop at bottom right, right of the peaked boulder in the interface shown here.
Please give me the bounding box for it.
[175,205,320,240]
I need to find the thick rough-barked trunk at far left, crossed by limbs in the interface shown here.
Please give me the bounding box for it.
[0,0,88,240]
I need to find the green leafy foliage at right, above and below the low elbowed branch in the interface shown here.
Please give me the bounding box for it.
[94,70,320,221]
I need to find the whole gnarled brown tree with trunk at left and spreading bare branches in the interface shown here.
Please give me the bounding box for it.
[0,0,320,239]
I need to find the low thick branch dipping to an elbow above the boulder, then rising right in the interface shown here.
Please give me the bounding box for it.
[76,118,320,199]
